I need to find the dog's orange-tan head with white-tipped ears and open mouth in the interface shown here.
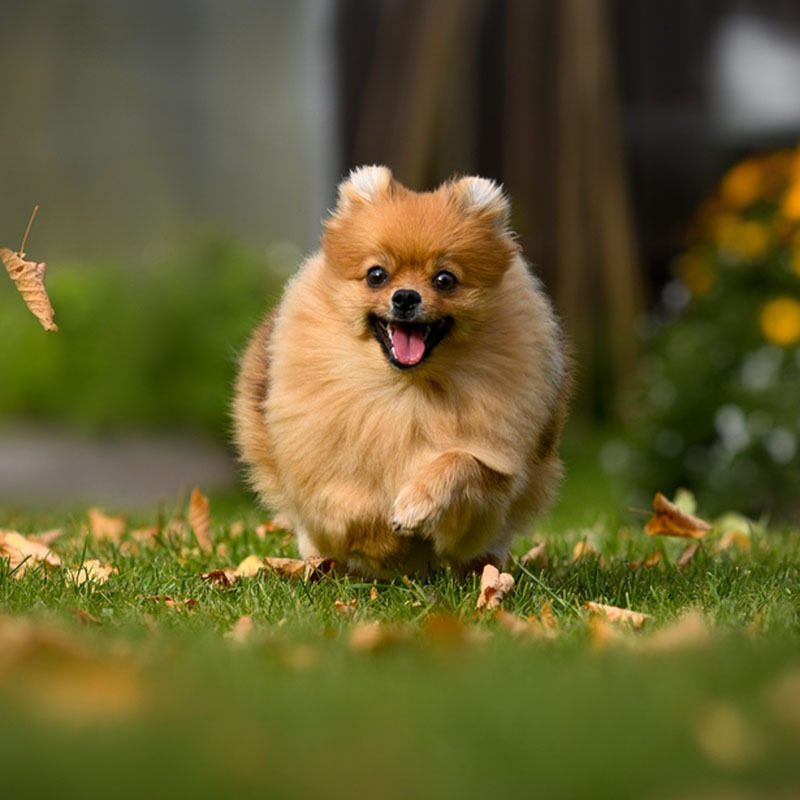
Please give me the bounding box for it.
[322,167,517,370]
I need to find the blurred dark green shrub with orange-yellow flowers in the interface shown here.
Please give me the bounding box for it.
[624,148,800,518]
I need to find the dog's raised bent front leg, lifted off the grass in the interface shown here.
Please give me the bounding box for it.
[391,450,511,551]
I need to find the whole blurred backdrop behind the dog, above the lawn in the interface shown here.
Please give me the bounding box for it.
[0,0,800,520]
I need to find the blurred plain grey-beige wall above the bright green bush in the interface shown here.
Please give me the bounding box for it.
[0,0,338,261]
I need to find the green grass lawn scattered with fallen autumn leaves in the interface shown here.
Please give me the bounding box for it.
[0,450,800,798]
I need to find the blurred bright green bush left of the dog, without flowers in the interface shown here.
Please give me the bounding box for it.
[0,240,288,436]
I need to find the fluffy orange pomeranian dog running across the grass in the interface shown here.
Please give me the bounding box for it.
[233,166,569,576]
